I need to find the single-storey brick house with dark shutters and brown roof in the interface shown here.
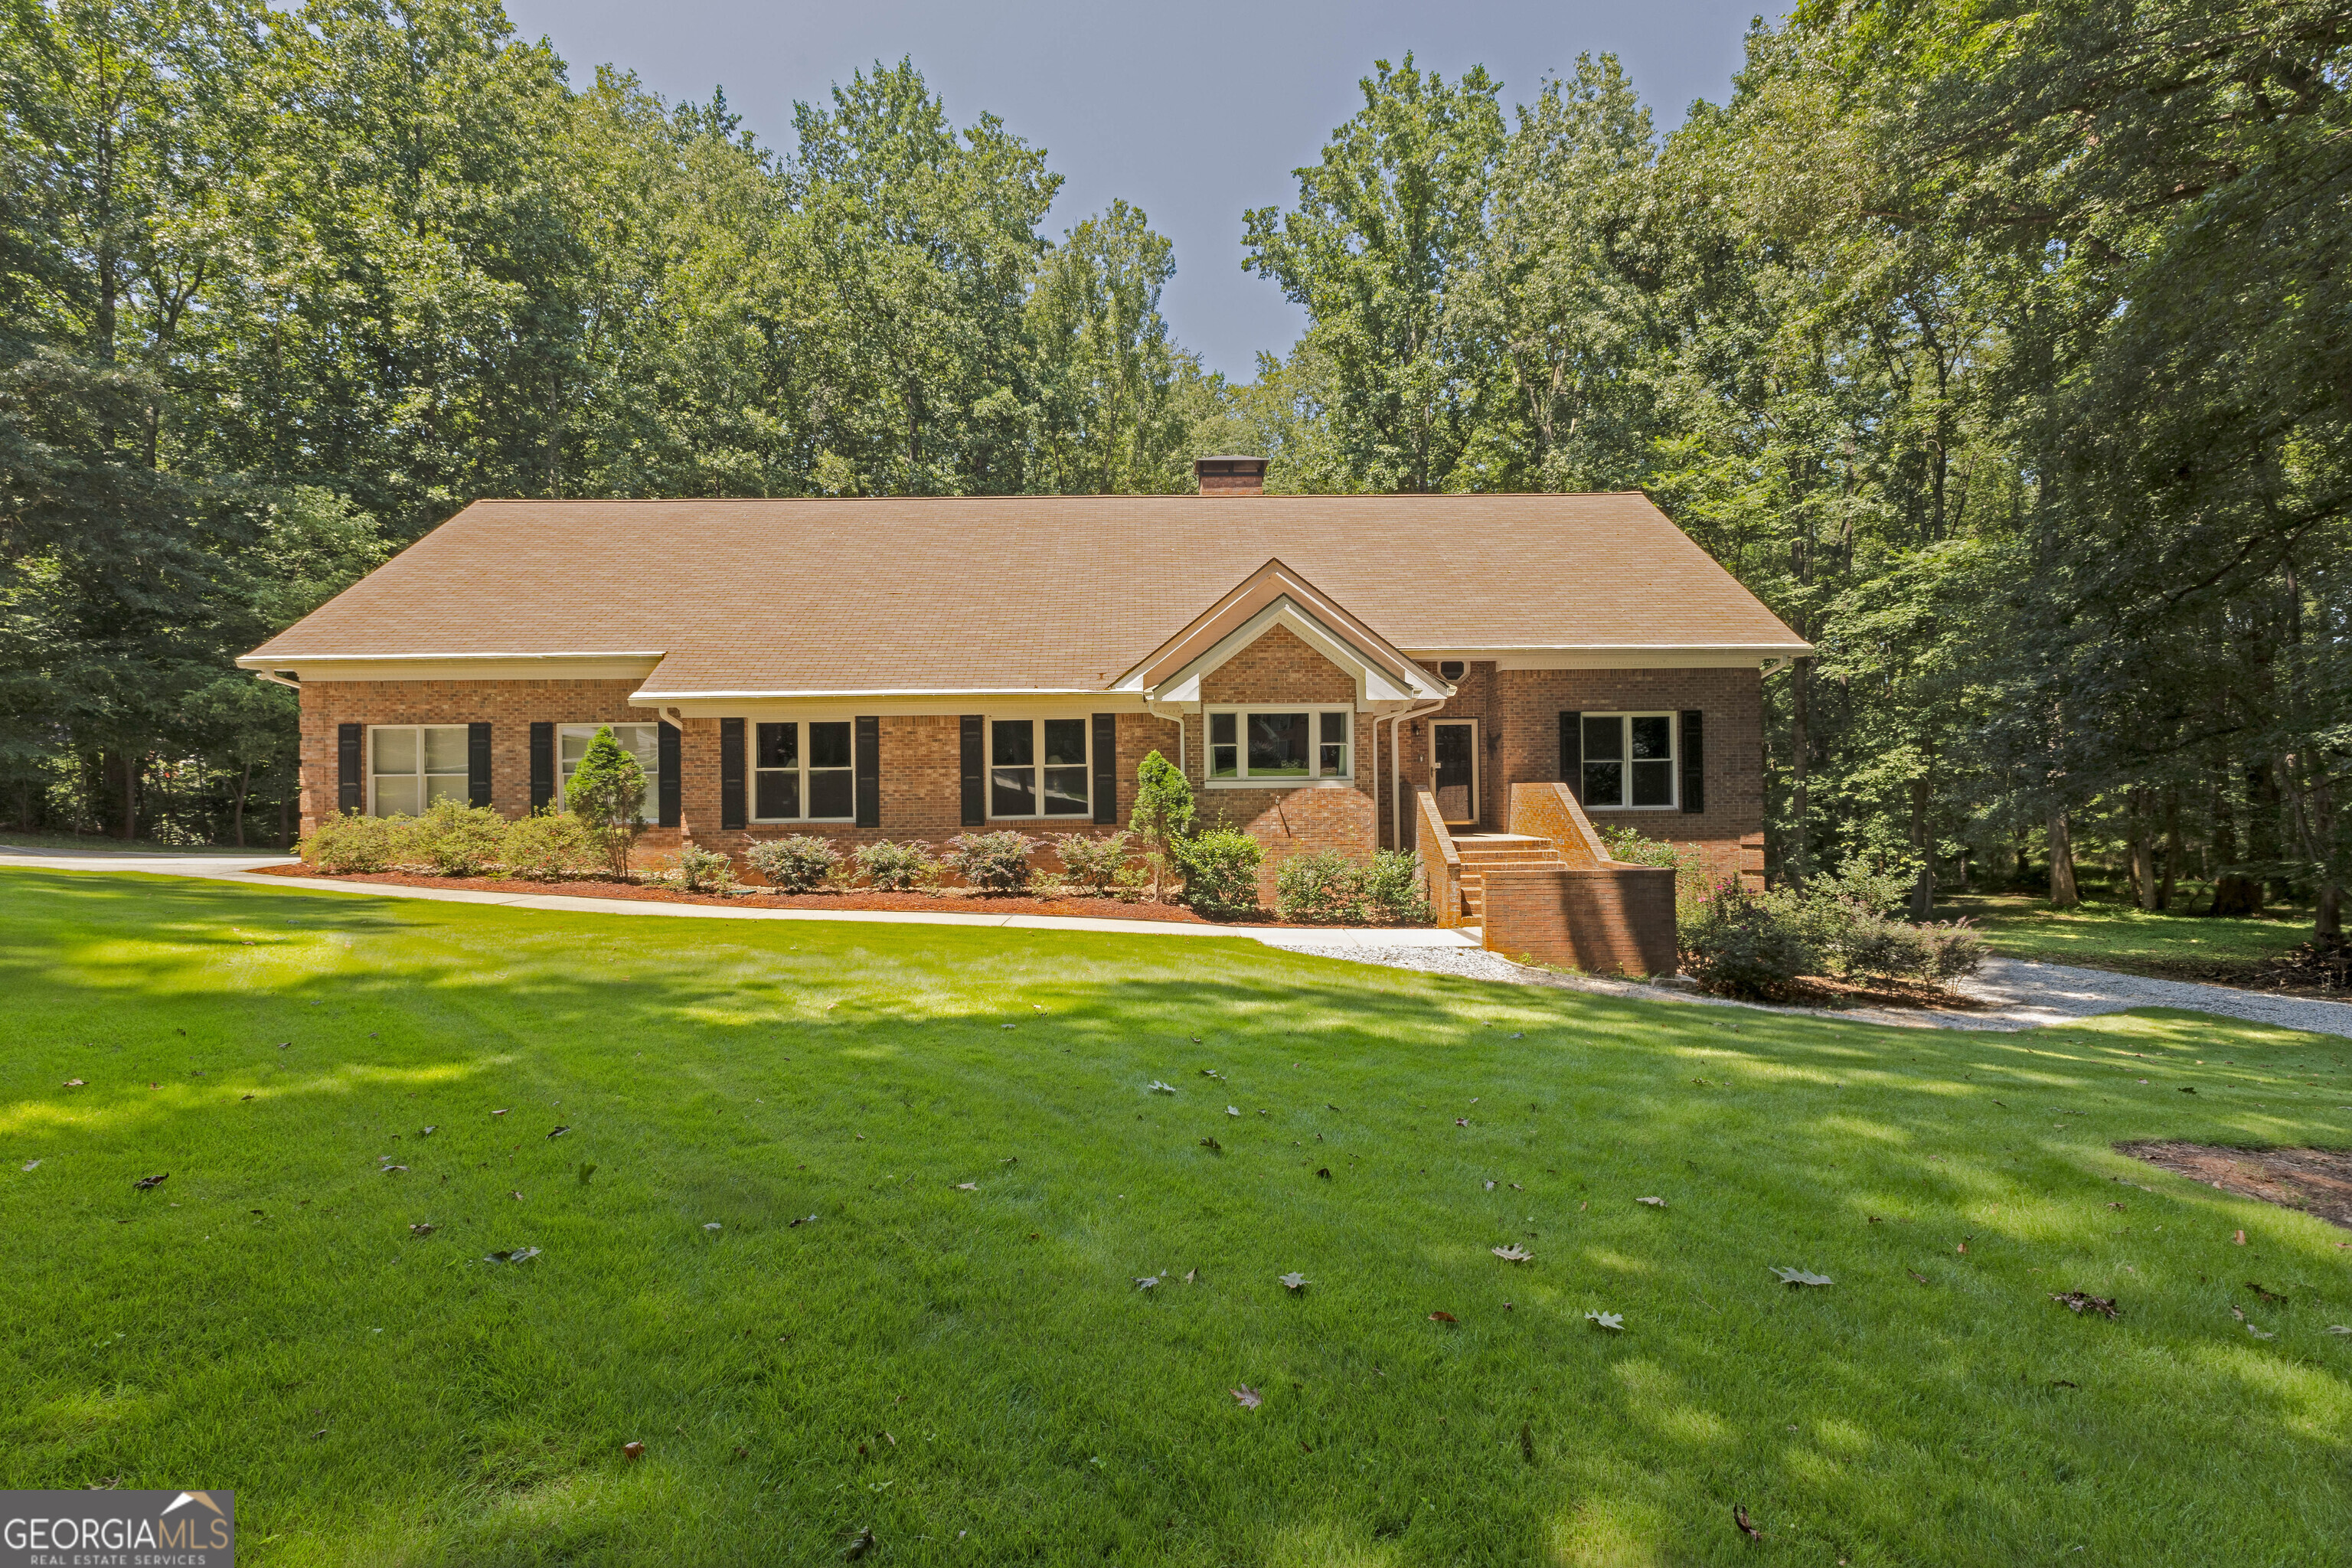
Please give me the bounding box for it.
[237,459,1806,969]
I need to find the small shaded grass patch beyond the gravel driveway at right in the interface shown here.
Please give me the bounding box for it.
[1936,893,2312,980]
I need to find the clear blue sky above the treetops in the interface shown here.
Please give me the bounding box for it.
[505,0,1757,381]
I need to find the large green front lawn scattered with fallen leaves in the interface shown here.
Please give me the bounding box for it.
[0,872,2352,1568]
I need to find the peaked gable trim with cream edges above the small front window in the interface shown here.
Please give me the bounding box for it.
[1110,560,1453,705]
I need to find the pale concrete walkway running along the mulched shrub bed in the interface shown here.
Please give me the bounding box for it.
[0,846,1477,947]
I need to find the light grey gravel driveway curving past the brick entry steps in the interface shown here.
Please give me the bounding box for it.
[1270,938,2352,1039]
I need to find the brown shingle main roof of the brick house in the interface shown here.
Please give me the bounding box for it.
[242,494,1804,694]
